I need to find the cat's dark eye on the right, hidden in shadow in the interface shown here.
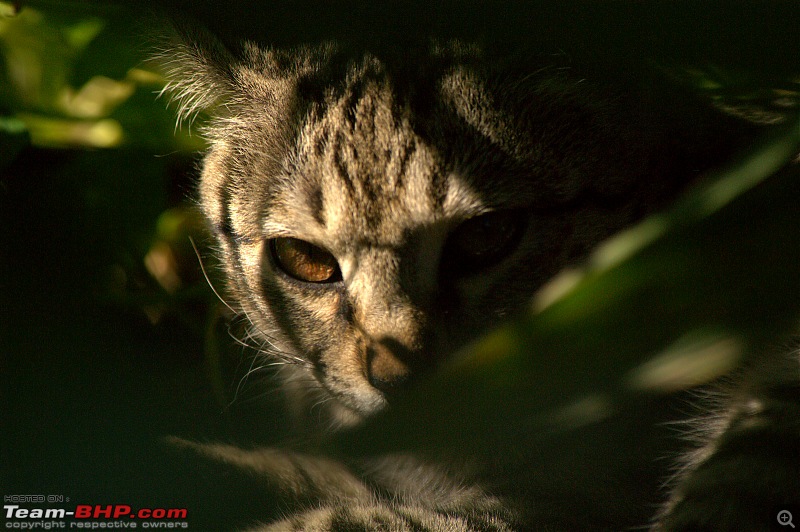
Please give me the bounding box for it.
[444,211,524,272]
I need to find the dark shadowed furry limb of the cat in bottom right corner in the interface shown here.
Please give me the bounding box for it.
[654,381,800,532]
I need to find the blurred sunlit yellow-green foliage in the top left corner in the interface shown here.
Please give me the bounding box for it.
[0,2,203,153]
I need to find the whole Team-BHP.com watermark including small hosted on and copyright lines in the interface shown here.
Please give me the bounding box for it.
[3,495,189,530]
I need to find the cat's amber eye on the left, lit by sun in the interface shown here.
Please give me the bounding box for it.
[272,237,341,283]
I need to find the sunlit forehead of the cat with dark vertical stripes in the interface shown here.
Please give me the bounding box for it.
[291,81,478,240]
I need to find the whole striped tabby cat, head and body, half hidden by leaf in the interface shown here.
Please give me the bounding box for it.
[153,19,800,530]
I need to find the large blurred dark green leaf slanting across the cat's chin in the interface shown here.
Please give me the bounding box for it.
[334,118,800,455]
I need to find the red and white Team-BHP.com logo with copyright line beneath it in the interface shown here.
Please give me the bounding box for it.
[3,504,188,529]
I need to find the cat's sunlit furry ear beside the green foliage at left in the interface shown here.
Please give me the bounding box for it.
[151,20,238,127]
